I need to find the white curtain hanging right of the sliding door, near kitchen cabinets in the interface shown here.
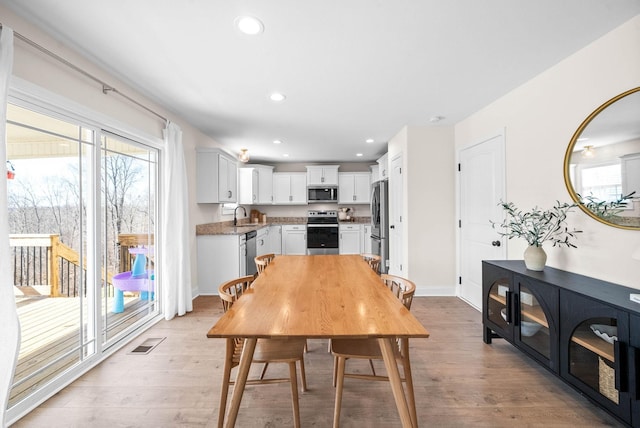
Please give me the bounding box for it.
[161,122,193,320]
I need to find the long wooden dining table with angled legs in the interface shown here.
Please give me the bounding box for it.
[207,255,429,427]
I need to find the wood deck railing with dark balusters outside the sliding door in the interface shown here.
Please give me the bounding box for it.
[9,234,153,297]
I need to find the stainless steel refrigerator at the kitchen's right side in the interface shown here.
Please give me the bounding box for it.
[371,180,389,273]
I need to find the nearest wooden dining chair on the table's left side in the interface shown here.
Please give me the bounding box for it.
[218,275,307,427]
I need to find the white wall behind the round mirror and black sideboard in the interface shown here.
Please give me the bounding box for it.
[455,16,640,288]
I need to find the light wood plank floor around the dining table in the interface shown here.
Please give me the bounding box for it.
[14,297,621,428]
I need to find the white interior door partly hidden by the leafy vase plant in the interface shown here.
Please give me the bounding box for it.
[458,133,506,310]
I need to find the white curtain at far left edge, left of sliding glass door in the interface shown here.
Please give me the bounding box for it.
[0,26,20,427]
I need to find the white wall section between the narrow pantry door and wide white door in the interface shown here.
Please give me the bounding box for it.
[389,126,457,296]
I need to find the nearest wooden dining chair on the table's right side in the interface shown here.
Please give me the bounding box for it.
[330,274,418,428]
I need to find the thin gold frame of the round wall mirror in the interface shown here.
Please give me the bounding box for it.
[564,87,640,230]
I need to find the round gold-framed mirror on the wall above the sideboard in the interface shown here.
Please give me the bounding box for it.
[564,87,640,230]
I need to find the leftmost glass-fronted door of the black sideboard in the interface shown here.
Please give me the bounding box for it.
[482,264,516,343]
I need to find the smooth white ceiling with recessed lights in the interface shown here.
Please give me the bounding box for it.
[0,0,640,162]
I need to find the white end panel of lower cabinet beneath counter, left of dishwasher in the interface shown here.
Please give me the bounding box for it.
[196,234,246,295]
